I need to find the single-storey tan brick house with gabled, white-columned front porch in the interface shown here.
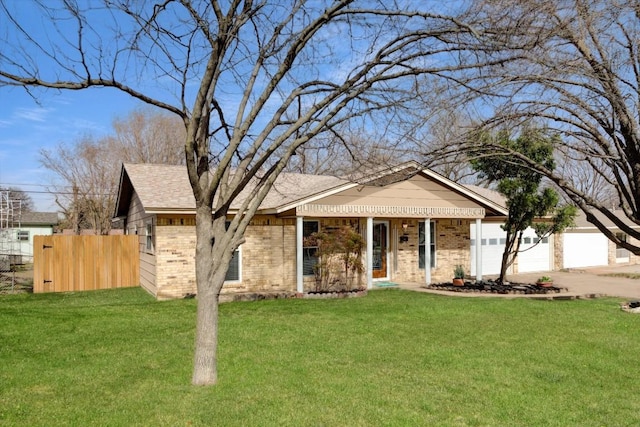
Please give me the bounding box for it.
[115,163,507,299]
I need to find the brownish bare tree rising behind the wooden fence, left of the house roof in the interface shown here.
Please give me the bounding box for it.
[40,107,185,234]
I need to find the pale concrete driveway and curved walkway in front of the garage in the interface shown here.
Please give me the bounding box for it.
[399,265,640,300]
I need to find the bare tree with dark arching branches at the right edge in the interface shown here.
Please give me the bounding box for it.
[436,0,640,254]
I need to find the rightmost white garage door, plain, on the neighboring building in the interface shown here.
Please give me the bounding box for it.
[562,233,609,268]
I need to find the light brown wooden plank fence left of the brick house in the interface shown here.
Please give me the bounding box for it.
[33,235,140,293]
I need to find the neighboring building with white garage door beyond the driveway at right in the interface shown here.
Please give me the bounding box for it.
[556,210,640,268]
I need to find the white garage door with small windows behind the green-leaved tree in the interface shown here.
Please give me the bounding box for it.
[471,223,551,276]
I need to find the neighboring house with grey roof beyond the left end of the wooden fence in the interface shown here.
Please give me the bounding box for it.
[0,212,59,264]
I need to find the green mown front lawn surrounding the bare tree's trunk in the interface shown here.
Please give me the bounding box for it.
[0,289,640,426]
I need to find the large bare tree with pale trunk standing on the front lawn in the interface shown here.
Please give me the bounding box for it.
[0,0,482,385]
